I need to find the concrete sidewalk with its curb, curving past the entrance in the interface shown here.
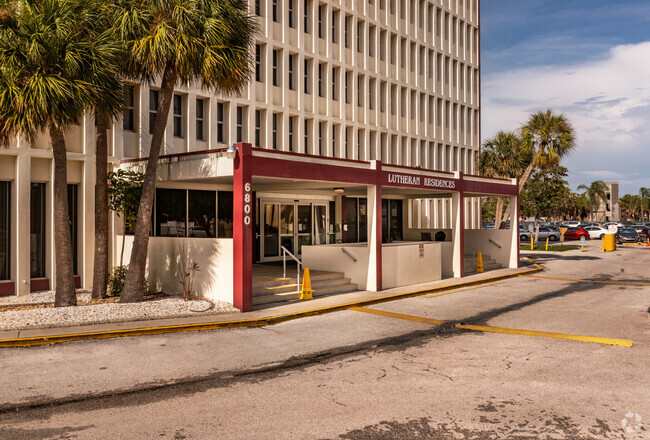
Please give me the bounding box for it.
[0,265,541,347]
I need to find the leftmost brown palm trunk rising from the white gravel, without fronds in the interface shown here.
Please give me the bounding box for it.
[50,126,77,307]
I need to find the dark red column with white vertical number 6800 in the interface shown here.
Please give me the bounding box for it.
[232,143,255,312]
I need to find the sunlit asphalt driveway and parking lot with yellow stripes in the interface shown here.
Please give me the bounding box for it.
[0,240,650,439]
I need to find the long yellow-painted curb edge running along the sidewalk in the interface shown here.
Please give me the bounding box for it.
[0,267,542,348]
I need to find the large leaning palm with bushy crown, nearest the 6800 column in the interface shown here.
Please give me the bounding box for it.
[115,0,257,302]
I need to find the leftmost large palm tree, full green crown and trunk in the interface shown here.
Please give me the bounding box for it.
[0,0,118,306]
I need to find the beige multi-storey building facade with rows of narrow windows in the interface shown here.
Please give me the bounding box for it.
[0,0,480,302]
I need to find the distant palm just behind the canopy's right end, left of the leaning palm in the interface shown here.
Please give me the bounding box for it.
[478,131,532,228]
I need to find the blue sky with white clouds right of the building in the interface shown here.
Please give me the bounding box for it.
[480,0,650,195]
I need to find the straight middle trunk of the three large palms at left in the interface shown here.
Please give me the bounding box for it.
[92,115,108,299]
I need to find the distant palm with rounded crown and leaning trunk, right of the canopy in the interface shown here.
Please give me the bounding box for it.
[503,109,576,227]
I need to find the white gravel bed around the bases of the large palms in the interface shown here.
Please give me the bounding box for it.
[0,291,239,330]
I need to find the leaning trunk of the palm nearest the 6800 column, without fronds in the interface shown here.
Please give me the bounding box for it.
[120,62,176,303]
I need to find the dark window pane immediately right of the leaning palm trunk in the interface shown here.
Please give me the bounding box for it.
[155,188,187,237]
